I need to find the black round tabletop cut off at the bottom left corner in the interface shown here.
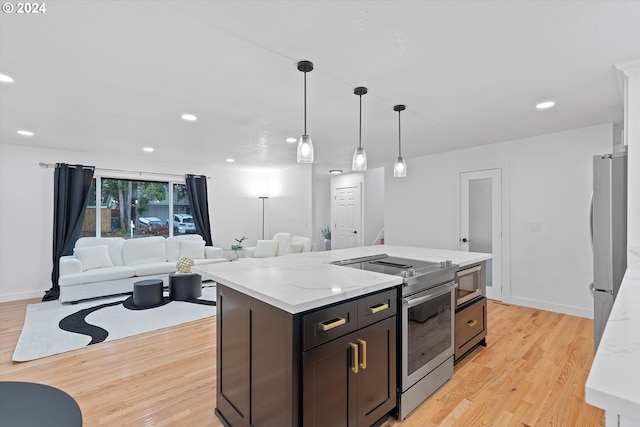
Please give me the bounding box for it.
[0,381,82,427]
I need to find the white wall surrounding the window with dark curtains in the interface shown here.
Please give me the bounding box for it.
[0,143,312,301]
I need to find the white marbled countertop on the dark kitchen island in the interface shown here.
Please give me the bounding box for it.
[192,245,491,314]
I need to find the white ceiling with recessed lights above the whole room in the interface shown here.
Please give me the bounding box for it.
[0,0,640,171]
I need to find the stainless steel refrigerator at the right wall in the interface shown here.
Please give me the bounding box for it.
[591,152,627,350]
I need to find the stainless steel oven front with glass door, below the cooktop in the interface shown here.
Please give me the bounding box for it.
[398,280,455,419]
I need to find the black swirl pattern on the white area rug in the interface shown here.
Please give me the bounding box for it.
[58,297,216,345]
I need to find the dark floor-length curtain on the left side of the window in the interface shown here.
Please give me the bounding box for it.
[42,163,95,301]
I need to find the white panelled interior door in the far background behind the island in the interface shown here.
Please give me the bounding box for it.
[331,186,362,249]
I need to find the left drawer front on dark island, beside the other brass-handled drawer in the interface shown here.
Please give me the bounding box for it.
[302,301,358,350]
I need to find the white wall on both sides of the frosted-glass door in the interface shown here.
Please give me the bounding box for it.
[385,124,613,317]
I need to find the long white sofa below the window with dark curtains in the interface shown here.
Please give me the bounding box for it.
[58,234,226,303]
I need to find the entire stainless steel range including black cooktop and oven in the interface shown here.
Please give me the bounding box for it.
[335,254,458,419]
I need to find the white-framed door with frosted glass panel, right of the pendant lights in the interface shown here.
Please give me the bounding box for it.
[460,169,502,300]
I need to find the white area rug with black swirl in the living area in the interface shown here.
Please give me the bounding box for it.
[13,285,216,362]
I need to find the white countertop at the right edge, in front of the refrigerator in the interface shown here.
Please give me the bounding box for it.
[585,246,640,425]
